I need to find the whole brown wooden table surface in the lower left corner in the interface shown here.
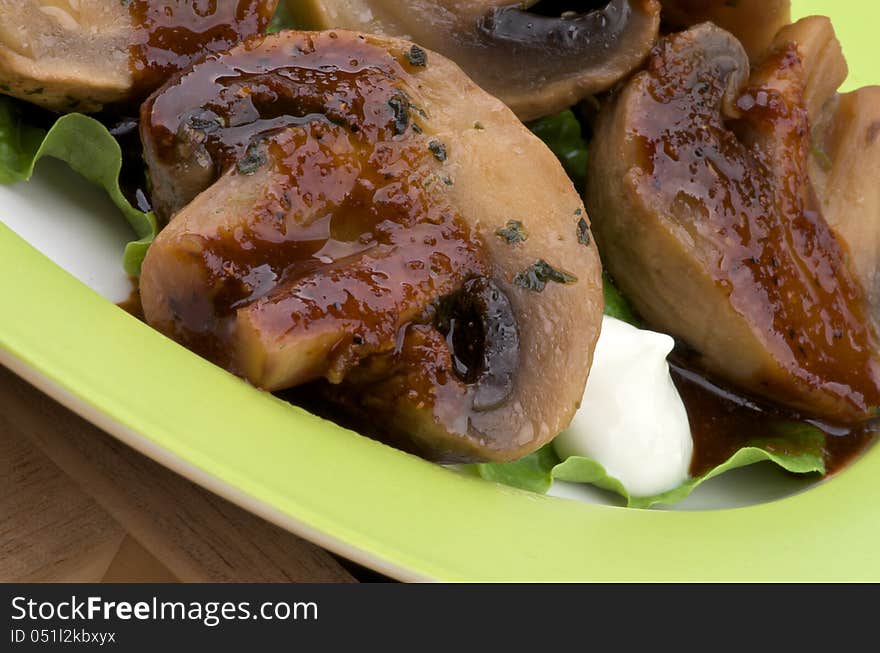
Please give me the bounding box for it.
[0,367,360,582]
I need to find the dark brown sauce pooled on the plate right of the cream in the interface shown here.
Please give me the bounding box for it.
[671,365,880,477]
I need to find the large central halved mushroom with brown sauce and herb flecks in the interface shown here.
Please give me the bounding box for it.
[141,31,602,461]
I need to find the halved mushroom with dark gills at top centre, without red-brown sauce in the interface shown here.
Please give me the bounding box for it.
[287,0,660,120]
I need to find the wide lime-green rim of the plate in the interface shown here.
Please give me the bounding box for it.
[0,1,880,581]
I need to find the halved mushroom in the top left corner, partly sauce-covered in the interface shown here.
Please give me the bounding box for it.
[0,0,278,111]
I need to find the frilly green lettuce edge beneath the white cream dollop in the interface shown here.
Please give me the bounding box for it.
[473,422,825,509]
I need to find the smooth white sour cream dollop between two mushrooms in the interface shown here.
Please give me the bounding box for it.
[553,317,693,497]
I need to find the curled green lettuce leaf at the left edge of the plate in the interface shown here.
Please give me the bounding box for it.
[0,97,158,276]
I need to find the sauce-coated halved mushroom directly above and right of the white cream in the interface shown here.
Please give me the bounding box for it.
[587,24,880,422]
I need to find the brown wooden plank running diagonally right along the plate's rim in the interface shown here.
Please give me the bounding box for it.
[0,367,353,582]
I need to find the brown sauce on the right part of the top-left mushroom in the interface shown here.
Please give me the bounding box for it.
[127,0,278,95]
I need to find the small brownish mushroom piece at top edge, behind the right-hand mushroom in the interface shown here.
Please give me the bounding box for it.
[662,0,791,61]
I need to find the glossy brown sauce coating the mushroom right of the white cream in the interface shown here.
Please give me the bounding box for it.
[639,35,880,415]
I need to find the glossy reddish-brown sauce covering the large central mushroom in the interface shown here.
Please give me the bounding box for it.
[141,34,486,428]
